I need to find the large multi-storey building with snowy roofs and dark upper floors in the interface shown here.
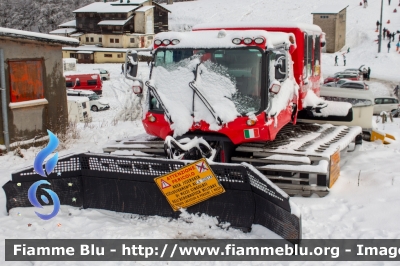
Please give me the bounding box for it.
[50,0,170,48]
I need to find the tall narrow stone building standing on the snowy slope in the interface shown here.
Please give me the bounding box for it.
[311,5,348,53]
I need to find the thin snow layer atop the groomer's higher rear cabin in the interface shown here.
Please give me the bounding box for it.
[192,22,322,32]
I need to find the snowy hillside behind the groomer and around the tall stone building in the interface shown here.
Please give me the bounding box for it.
[164,0,400,85]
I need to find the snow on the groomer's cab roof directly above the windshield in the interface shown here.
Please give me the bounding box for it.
[155,30,294,48]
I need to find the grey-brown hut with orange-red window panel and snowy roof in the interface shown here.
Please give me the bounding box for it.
[0,28,79,150]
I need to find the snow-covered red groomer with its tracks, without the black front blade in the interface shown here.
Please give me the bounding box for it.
[104,23,362,196]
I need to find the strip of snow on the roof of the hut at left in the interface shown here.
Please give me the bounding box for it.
[0,27,79,46]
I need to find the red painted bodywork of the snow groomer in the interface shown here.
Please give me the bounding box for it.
[143,27,322,144]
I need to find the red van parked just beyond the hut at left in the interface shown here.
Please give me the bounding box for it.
[64,72,103,95]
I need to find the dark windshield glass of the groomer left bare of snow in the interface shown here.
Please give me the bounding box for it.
[150,48,263,114]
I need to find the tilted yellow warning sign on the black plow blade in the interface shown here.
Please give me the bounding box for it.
[154,159,225,211]
